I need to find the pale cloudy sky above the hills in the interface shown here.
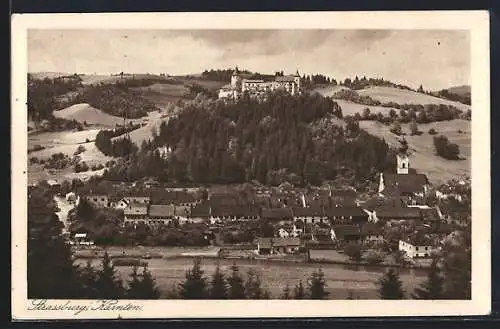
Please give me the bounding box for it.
[28,29,470,90]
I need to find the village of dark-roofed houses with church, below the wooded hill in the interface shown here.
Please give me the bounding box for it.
[33,136,470,267]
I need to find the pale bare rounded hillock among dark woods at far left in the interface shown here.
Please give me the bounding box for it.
[53,103,129,127]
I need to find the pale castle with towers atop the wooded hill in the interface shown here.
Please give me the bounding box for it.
[219,67,302,100]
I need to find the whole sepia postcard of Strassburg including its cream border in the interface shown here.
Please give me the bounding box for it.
[12,12,490,318]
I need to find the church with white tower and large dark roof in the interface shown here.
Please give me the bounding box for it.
[378,139,429,202]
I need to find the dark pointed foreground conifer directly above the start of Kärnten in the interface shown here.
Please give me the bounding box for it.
[96,252,124,299]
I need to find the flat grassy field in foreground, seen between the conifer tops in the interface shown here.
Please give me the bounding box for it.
[76,247,426,299]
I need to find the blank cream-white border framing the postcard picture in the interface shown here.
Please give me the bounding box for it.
[11,11,491,320]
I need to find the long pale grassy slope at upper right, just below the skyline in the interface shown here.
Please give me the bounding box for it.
[357,87,470,110]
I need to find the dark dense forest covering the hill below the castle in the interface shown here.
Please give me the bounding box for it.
[105,93,392,190]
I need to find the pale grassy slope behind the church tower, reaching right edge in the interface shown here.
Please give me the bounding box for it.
[360,119,471,184]
